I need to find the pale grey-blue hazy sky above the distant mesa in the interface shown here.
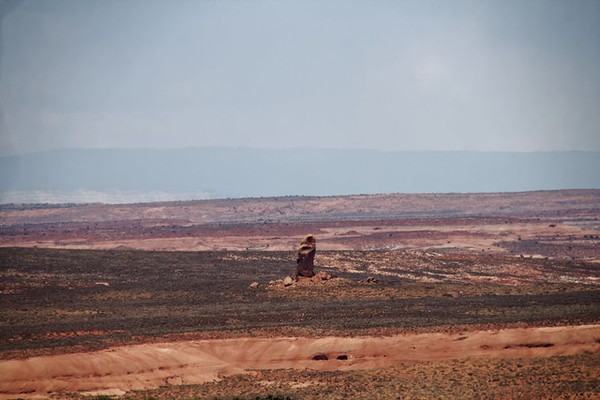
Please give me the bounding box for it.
[0,0,600,154]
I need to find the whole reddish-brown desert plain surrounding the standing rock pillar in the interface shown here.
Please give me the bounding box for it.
[0,190,600,399]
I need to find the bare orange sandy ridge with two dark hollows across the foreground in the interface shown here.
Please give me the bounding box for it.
[0,325,600,399]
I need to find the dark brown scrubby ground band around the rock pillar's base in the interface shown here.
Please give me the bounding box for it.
[0,248,600,358]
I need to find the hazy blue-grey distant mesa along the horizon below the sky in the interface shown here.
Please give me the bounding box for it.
[0,148,600,198]
